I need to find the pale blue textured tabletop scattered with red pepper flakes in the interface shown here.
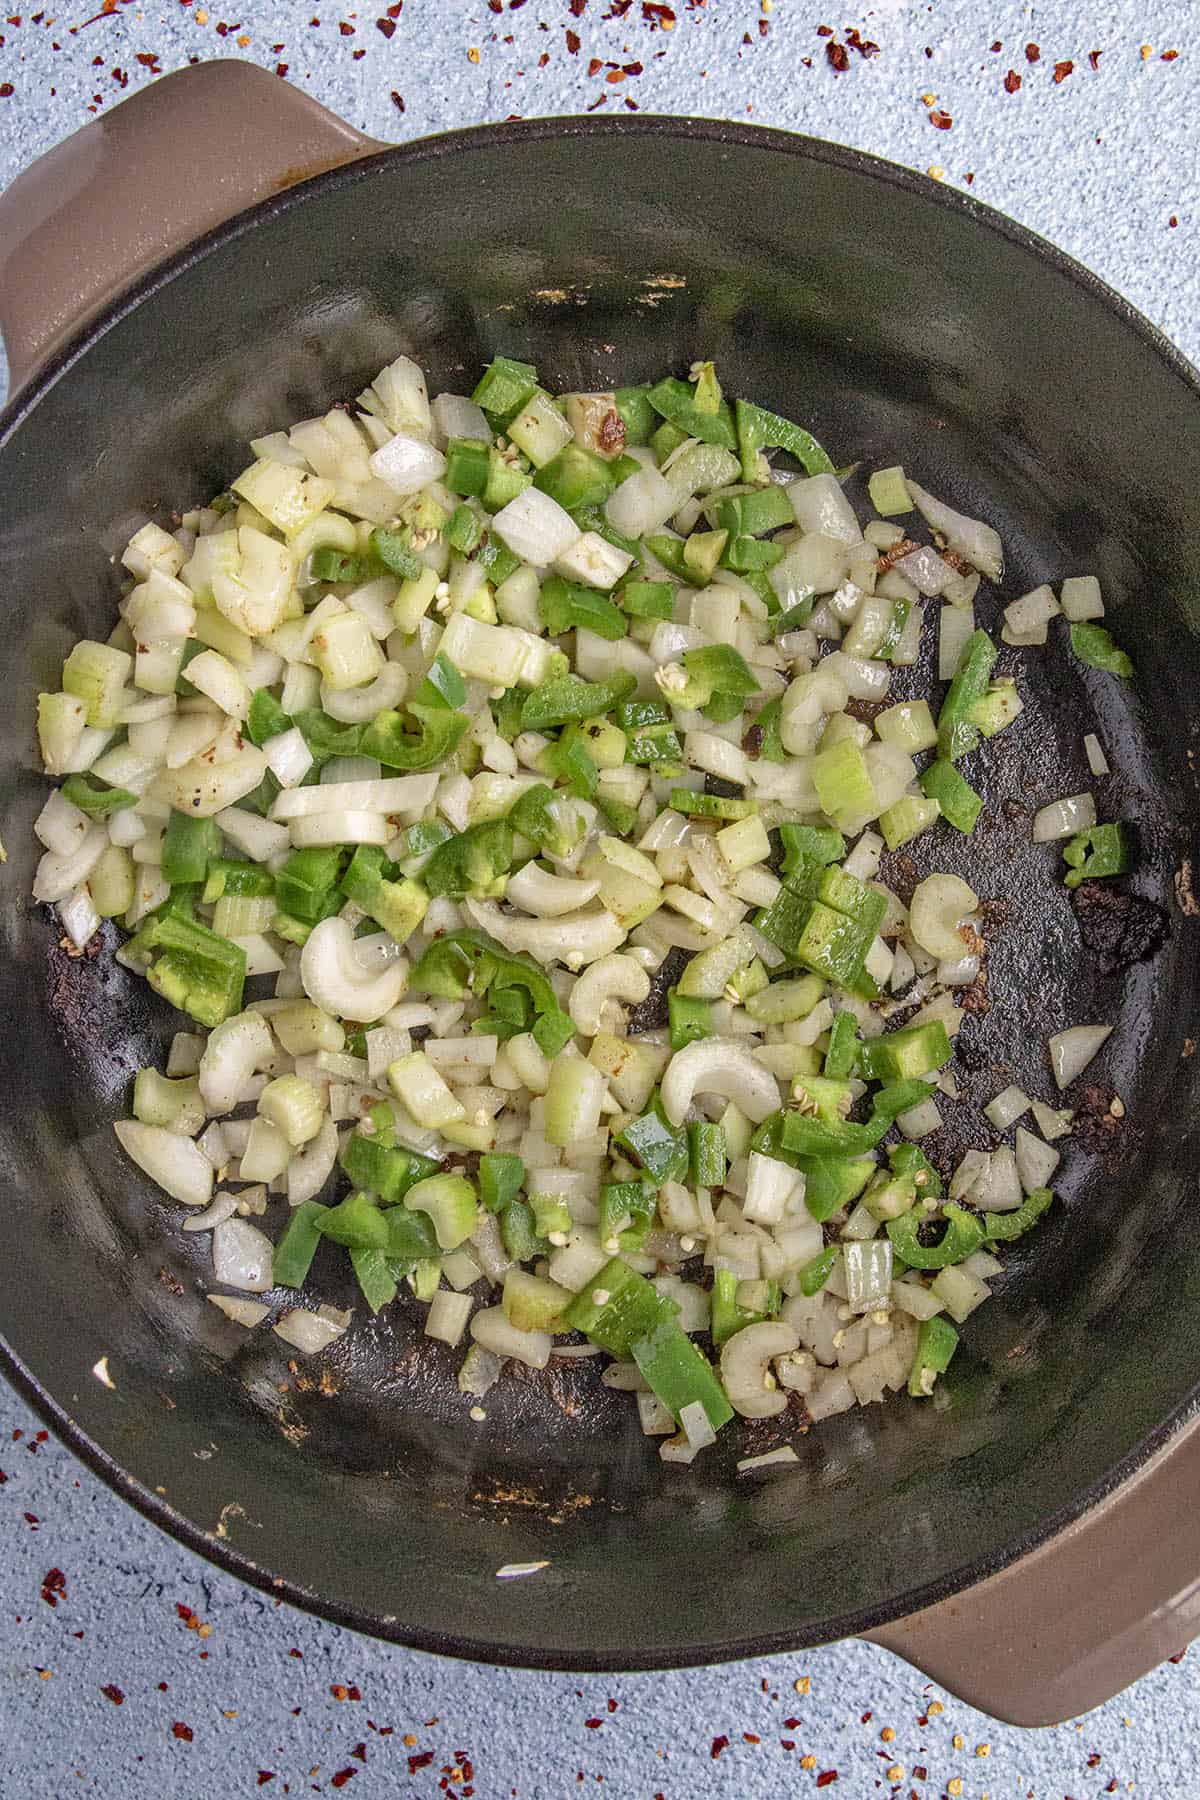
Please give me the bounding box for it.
[0,0,1200,1800]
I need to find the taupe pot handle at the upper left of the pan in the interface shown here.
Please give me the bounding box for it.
[0,59,385,405]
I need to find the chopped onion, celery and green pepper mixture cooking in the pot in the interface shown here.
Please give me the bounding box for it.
[34,356,1132,1463]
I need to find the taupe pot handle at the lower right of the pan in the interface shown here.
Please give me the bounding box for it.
[867,1418,1200,1724]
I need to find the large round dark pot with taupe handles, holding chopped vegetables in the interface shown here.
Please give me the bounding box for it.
[0,65,1200,1719]
